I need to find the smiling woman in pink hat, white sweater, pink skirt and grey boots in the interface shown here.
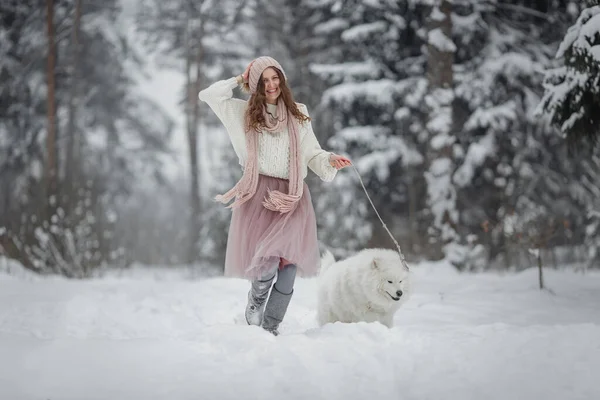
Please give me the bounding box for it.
[198,57,351,335]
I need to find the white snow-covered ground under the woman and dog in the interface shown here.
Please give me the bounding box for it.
[0,260,600,400]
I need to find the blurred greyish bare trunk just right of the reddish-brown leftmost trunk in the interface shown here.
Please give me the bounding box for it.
[64,0,81,215]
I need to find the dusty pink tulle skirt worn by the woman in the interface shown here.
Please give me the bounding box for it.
[225,174,320,279]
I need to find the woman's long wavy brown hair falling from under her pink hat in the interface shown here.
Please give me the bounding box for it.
[246,67,311,132]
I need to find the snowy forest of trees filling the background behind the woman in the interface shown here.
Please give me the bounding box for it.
[0,0,600,277]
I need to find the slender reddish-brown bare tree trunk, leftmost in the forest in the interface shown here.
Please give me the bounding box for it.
[46,0,58,220]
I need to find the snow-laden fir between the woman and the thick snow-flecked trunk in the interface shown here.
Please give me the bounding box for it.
[311,0,426,254]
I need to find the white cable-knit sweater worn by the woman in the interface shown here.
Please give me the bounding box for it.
[198,77,337,182]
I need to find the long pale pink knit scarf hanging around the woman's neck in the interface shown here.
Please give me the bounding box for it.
[215,101,304,214]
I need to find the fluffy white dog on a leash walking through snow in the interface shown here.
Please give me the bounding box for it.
[317,249,410,328]
